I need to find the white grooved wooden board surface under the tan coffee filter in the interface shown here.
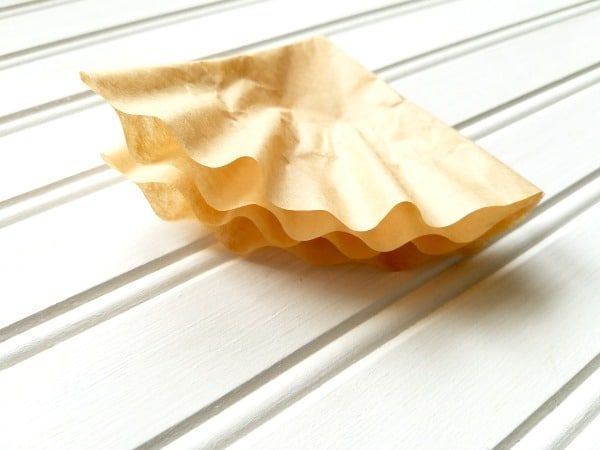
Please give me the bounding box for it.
[0,0,600,449]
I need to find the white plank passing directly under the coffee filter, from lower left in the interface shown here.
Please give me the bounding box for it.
[0,89,600,447]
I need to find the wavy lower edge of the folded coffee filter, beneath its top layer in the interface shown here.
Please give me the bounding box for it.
[104,144,542,258]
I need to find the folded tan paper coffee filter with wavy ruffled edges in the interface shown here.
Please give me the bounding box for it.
[81,38,542,269]
